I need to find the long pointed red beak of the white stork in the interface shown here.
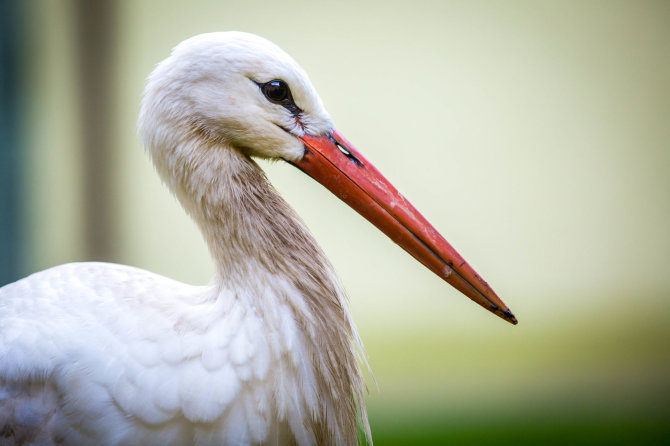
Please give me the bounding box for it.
[293,130,517,325]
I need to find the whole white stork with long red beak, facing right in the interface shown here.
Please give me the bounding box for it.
[0,32,516,446]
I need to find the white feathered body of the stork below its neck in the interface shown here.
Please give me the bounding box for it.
[0,263,362,445]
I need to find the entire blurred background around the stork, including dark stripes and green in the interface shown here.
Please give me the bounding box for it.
[0,0,670,445]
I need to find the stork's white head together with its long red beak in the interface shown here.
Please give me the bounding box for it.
[139,32,516,324]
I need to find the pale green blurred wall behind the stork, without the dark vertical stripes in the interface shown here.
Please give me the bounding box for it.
[19,0,670,432]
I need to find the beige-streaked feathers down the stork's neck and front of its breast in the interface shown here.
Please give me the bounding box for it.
[165,139,369,444]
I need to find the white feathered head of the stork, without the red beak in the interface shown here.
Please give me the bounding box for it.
[139,32,333,161]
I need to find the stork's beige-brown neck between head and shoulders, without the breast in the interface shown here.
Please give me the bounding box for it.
[180,147,312,284]
